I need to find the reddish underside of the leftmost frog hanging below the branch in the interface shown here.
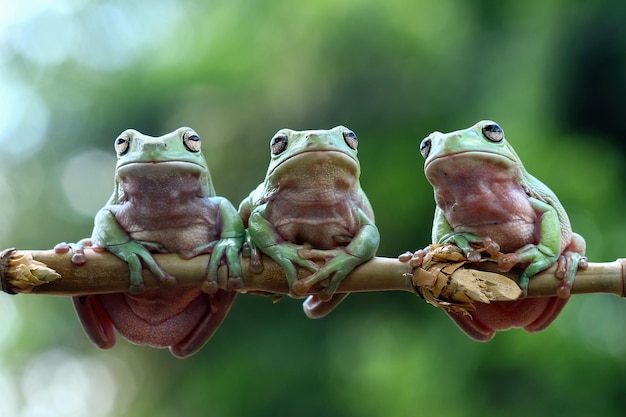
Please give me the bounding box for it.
[98,288,236,358]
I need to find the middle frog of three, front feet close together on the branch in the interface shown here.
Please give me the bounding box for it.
[239,126,380,319]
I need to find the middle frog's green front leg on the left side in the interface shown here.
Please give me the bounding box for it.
[248,205,319,296]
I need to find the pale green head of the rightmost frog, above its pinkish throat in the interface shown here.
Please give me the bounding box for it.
[420,120,522,178]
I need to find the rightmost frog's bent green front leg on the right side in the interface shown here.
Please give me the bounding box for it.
[498,198,560,296]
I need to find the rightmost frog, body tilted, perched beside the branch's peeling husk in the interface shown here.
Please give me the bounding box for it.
[420,120,587,342]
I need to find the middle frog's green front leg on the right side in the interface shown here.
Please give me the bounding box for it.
[293,209,380,301]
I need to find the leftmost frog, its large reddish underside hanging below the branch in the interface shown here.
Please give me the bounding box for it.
[56,127,245,358]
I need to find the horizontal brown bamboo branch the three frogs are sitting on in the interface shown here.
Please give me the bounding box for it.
[0,245,626,301]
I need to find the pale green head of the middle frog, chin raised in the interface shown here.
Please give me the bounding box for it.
[267,126,360,184]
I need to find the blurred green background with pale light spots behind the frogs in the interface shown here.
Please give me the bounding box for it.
[0,0,626,417]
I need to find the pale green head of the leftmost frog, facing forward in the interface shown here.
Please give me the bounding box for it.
[108,127,215,197]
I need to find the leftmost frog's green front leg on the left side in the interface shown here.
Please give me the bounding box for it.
[91,207,176,294]
